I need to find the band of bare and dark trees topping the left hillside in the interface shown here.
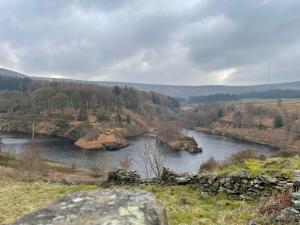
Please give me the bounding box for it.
[0,78,179,121]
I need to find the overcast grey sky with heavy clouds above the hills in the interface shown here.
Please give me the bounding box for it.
[0,0,300,85]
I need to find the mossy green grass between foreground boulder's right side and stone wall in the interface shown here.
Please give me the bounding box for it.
[142,186,258,225]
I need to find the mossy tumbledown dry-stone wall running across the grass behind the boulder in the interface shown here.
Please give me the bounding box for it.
[102,168,292,199]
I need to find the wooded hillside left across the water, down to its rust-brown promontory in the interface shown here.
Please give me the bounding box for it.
[0,76,179,149]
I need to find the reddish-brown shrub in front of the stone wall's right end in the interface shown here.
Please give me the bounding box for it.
[257,191,292,215]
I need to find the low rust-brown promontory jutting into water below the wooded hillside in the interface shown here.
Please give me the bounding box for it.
[75,134,128,150]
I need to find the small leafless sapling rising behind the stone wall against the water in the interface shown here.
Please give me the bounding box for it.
[140,141,166,178]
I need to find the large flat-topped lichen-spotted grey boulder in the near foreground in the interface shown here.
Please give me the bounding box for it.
[14,189,168,225]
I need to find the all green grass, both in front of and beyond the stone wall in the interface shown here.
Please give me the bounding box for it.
[0,154,300,225]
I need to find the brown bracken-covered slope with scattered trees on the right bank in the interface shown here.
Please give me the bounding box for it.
[189,101,300,149]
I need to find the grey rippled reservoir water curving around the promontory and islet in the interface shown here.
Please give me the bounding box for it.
[0,131,274,176]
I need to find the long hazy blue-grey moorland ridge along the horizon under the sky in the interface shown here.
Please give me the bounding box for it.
[0,68,300,98]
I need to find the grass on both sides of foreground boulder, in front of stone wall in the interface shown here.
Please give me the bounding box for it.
[0,182,264,225]
